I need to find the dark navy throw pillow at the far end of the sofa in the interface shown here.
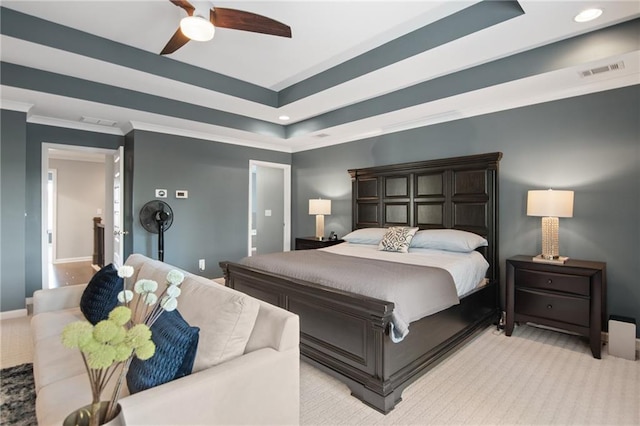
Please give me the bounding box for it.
[80,263,123,325]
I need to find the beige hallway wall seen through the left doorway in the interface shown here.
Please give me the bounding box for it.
[49,159,105,261]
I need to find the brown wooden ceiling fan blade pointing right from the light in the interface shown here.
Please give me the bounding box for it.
[209,7,291,38]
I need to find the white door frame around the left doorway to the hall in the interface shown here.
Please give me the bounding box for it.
[40,142,117,289]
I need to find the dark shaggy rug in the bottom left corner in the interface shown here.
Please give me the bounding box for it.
[0,364,36,426]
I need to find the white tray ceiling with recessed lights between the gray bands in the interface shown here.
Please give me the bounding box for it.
[0,0,640,152]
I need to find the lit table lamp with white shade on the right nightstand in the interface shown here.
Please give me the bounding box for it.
[527,189,573,263]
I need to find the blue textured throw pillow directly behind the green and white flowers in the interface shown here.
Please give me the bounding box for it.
[127,310,200,394]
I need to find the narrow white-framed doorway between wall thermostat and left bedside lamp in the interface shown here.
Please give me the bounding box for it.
[248,160,291,256]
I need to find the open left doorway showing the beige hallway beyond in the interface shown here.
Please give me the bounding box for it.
[41,144,113,288]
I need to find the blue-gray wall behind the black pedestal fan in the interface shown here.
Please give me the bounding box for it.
[128,130,291,278]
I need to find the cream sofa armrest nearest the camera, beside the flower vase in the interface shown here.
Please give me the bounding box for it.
[120,348,300,425]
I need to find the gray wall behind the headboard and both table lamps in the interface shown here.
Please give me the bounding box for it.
[292,86,640,336]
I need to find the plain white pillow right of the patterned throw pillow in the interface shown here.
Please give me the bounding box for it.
[411,229,489,253]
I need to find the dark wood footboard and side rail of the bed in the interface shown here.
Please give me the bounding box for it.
[220,262,497,414]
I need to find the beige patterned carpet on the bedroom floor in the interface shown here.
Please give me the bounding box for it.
[0,317,640,425]
